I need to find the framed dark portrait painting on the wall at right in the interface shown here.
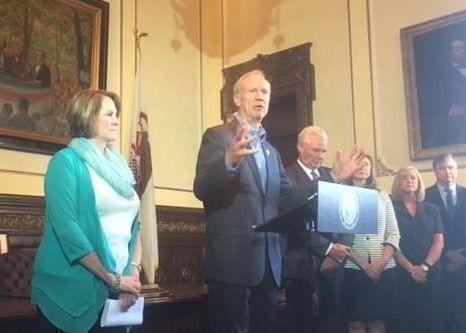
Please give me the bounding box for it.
[401,11,466,160]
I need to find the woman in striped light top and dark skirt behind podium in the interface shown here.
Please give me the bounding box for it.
[343,156,400,333]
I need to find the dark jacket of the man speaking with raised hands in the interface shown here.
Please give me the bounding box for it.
[194,119,291,286]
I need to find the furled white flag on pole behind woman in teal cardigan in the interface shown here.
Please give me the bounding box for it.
[129,49,159,283]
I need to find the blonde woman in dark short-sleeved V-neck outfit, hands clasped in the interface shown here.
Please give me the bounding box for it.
[392,166,443,333]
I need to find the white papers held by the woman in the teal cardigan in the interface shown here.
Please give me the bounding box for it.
[100,297,144,327]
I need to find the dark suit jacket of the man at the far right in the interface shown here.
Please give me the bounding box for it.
[425,184,466,251]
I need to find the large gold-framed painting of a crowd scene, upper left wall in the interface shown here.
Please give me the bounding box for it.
[0,0,109,154]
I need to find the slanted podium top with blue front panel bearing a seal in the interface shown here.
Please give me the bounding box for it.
[253,181,378,234]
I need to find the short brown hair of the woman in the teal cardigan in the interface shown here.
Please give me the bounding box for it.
[66,89,121,139]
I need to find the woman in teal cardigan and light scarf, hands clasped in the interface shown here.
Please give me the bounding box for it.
[31,90,141,332]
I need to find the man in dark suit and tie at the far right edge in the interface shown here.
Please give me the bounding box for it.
[425,154,466,333]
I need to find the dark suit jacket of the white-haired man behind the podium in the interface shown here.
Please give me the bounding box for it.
[283,162,347,279]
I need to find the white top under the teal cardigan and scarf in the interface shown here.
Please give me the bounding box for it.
[88,166,139,274]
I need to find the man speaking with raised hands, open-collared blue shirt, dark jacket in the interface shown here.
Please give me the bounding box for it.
[194,70,291,333]
